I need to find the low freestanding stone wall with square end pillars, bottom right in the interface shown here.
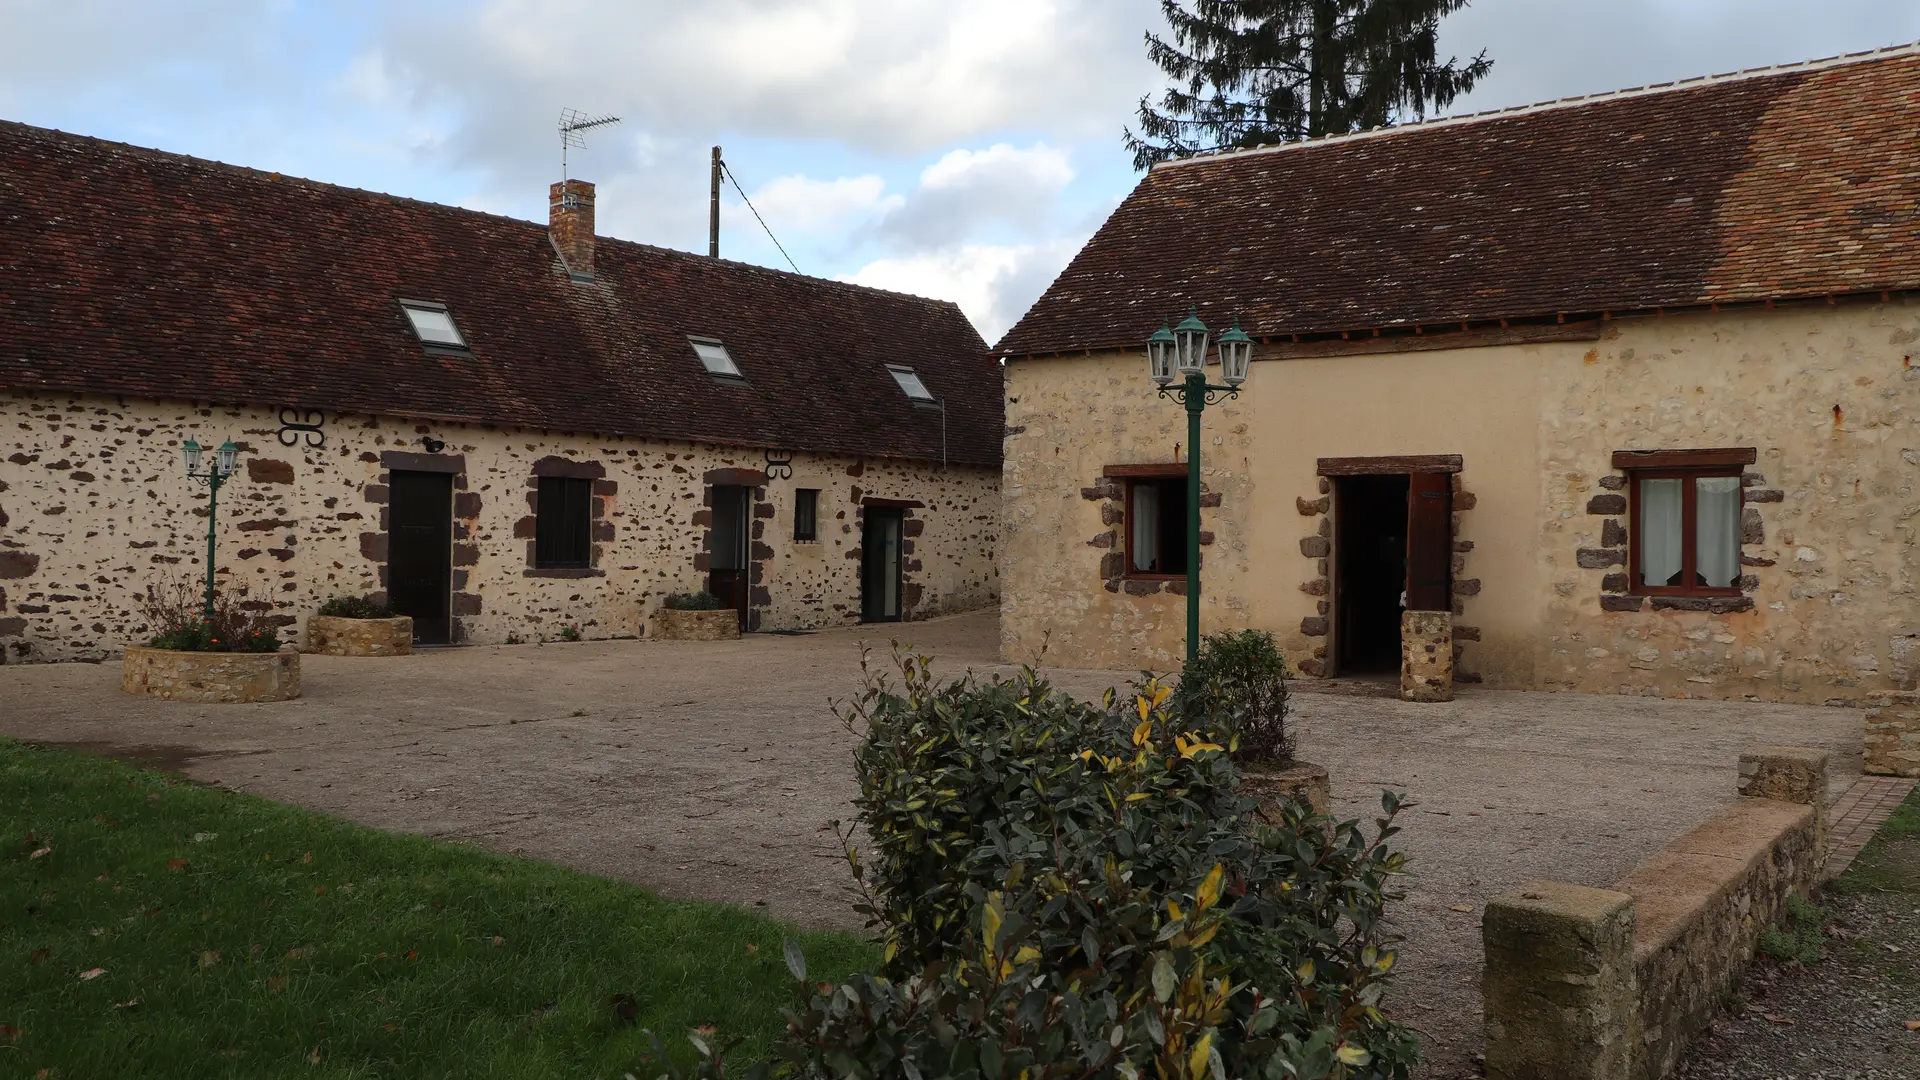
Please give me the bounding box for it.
[1480,748,1826,1080]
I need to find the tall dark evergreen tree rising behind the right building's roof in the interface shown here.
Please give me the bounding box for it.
[1127,0,1494,169]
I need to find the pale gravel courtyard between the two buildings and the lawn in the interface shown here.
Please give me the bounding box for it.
[0,613,1860,1076]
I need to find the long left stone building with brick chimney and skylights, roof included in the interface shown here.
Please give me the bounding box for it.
[0,123,1002,661]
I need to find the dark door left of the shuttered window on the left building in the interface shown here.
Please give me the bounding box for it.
[386,473,453,646]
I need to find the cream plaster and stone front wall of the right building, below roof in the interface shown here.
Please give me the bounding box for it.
[1002,302,1920,701]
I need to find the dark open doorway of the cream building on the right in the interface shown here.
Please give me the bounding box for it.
[1334,473,1409,675]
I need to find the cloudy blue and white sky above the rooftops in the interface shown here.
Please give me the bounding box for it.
[0,0,1920,340]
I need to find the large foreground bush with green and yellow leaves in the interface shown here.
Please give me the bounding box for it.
[756,645,1415,1080]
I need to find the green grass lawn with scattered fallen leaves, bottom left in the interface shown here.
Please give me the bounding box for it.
[0,740,877,1080]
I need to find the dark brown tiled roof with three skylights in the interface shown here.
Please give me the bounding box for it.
[0,123,1002,465]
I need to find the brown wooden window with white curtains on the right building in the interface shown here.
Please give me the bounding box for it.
[1613,448,1757,596]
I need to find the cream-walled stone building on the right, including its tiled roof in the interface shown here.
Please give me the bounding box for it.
[995,48,1920,701]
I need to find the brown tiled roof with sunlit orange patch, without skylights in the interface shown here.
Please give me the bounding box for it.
[996,46,1920,356]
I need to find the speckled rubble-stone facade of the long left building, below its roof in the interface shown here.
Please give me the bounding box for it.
[0,392,1000,661]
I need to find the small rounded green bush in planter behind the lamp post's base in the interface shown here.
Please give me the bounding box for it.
[1175,630,1294,765]
